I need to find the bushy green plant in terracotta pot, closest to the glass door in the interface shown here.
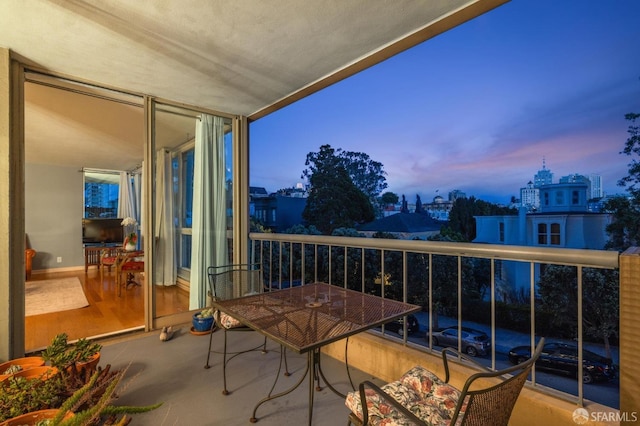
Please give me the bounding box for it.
[42,333,102,371]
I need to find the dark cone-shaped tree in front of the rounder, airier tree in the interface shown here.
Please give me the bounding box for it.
[302,145,375,235]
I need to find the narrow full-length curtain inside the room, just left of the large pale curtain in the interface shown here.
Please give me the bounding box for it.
[153,149,177,286]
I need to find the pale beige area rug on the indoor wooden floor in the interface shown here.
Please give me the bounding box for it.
[25,277,89,317]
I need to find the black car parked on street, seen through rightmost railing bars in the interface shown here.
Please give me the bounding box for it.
[509,342,616,383]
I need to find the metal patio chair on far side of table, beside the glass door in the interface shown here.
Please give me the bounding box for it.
[204,264,267,395]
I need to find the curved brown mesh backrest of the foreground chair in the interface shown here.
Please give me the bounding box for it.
[451,338,544,426]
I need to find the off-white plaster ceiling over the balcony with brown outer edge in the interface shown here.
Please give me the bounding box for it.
[0,0,507,171]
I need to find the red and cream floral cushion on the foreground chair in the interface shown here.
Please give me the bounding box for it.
[345,366,464,426]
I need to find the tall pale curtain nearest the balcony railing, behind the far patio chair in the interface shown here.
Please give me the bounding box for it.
[189,114,228,309]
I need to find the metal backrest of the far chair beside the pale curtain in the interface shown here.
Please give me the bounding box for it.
[207,264,264,300]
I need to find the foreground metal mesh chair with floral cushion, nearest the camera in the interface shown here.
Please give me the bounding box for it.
[345,338,544,426]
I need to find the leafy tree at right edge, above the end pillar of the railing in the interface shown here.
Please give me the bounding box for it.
[605,113,640,251]
